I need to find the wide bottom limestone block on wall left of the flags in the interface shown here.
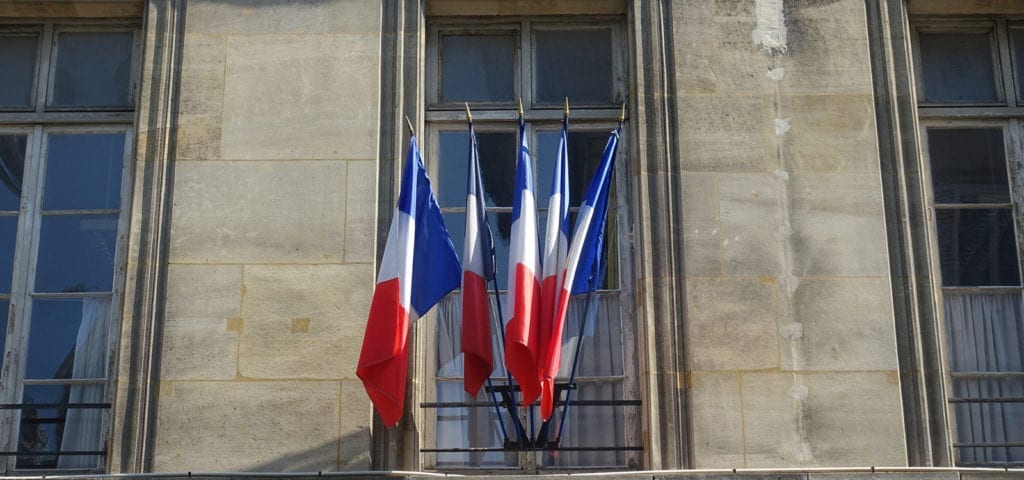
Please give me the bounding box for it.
[153,382,340,472]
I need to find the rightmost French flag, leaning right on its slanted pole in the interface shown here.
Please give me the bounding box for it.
[541,124,622,420]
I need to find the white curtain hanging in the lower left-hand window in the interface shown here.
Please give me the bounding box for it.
[57,298,111,469]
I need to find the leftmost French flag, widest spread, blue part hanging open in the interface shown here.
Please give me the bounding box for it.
[355,136,461,427]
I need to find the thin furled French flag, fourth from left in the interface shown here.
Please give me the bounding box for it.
[539,117,569,420]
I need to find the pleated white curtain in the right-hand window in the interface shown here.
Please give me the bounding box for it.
[944,292,1024,464]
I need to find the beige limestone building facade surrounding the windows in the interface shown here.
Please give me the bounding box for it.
[0,0,1024,474]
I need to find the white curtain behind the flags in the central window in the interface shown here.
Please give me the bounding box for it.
[436,295,625,467]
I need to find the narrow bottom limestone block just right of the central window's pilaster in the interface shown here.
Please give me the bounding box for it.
[690,373,746,469]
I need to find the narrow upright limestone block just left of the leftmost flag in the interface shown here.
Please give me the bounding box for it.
[345,161,377,263]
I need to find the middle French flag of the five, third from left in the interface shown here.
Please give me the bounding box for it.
[505,119,541,404]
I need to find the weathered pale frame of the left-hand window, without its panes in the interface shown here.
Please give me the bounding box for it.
[0,19,141,474]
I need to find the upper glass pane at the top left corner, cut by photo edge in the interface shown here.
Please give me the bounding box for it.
[0,34,39,106]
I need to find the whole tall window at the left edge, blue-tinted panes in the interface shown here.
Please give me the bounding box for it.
[0,23,139,472]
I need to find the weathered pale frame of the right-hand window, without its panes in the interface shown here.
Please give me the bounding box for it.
[910,17,1024,467]
